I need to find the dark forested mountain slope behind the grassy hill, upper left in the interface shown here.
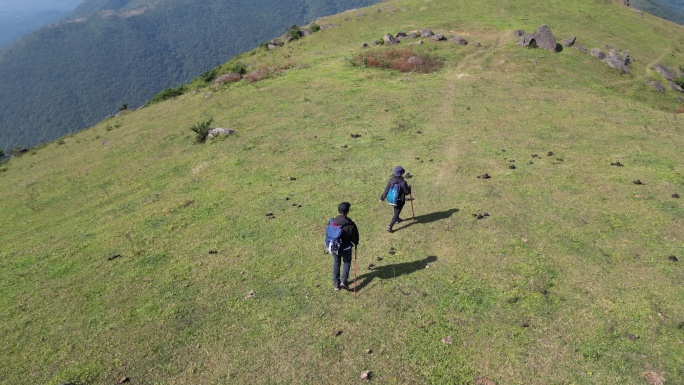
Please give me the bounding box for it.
[0,0,377,149]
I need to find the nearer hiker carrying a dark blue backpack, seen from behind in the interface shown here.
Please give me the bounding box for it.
[326,202,359,291]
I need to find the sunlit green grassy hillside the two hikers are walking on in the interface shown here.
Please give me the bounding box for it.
[0,0,684,385]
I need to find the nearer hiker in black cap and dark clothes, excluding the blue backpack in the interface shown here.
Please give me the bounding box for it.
[333,202,359,290]
